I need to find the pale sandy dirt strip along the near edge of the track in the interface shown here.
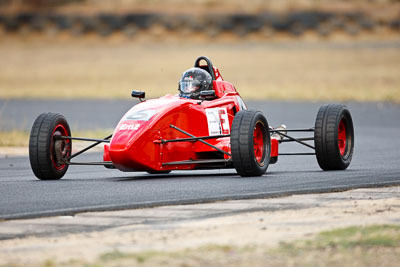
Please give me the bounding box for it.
[0,187,400,266]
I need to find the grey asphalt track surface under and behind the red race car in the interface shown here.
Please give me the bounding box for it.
[0,100,400,219]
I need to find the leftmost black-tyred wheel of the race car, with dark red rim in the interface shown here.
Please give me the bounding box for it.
[29,113,72,180]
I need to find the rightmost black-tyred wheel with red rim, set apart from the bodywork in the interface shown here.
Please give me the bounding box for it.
[314,104,354,170]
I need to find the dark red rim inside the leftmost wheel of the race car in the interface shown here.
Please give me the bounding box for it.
[50,124,71,171]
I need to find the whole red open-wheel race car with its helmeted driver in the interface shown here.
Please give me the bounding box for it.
[29,57,354,180]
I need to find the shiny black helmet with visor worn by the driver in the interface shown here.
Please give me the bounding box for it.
[178,68,212,99]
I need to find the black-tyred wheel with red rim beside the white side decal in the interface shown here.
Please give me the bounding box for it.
[231,110,271,176]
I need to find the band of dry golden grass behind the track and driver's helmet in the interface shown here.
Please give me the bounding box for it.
[0,41,400,103]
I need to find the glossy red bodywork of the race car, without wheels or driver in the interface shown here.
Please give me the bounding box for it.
[103,67,278,172]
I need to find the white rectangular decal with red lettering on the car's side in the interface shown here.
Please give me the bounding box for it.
[206,108,231,135]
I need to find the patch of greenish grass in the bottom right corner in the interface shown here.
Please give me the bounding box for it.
[267,225,400,267]
